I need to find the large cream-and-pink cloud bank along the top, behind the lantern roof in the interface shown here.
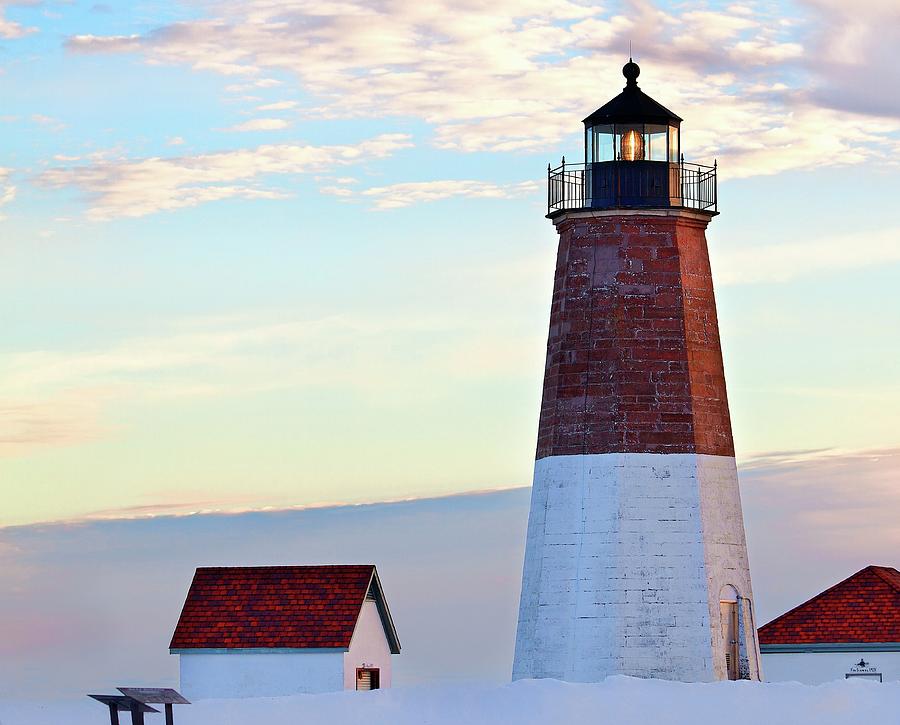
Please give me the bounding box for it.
[56,0,900,176]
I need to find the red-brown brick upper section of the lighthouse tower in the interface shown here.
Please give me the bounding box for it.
[537,210,734,459]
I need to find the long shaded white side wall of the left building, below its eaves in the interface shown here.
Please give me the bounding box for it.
[179,649,344,700]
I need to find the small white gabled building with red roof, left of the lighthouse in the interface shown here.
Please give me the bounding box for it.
[169,564,400,700]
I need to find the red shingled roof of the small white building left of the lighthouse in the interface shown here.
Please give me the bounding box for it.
[169,564,399,651]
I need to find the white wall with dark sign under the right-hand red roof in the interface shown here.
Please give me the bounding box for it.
[762,652,900,685]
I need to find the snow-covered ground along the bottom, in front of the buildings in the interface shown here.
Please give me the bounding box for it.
[0,677,900,725]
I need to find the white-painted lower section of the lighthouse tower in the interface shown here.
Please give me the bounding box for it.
[513,453,760,682]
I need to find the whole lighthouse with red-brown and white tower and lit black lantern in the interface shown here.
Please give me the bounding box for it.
[513,60,761,682]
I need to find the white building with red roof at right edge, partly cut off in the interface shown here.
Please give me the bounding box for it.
[759,566,900,684]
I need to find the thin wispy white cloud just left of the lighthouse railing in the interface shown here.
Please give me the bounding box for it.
[348,180,539,210]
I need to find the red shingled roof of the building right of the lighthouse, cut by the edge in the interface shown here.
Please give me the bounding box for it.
[759,566,900,645]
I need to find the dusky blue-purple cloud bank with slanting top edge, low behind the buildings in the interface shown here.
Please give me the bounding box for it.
[0,448,900,700]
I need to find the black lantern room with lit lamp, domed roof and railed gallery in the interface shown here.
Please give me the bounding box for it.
[547,59,716,218]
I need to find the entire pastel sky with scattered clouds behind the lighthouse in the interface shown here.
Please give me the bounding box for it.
[0,0,900,697]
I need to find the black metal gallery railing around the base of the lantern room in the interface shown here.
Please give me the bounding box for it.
[547,158,718,216]
